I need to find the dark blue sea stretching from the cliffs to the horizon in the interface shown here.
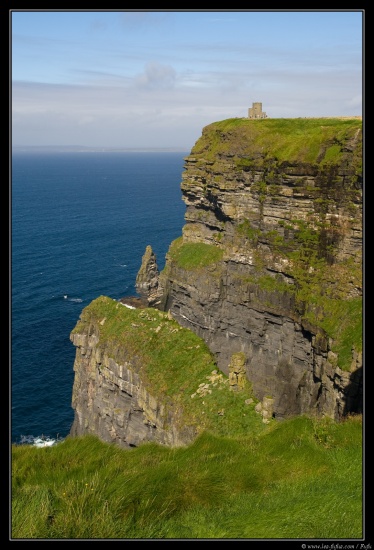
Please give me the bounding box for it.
[10,152,188,443]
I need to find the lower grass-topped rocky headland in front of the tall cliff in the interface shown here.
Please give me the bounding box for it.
[70,296,271,447]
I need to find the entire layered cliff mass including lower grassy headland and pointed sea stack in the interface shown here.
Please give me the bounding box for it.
[71,119,362,446]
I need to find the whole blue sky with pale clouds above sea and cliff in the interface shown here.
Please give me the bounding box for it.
[9,10,365,151]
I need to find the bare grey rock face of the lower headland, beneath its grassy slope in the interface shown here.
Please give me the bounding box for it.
[70,334,196,447]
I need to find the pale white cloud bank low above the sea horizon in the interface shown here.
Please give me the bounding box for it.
[12,73,361,150]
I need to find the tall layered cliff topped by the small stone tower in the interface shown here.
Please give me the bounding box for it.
[158,119,362,418]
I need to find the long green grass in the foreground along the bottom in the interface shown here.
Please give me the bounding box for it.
[11,416,363,540]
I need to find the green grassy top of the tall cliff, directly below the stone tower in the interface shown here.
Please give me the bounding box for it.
[188,117,362,166]
